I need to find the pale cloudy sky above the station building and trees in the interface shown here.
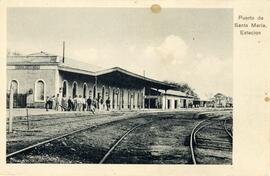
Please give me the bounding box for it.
[7,8,233,98]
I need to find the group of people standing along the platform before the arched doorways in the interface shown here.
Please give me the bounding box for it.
[45,94,110,114]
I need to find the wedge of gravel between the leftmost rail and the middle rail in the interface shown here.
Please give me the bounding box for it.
[8,115,173,163]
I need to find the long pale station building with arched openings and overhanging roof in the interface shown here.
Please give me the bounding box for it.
[7,51,192,110]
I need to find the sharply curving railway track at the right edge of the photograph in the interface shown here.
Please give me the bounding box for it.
[189,118,232,165]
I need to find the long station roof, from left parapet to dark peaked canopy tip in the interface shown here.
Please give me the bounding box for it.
[7,51,175,90]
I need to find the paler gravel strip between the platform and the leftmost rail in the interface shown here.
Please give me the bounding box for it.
[6,113,138,153]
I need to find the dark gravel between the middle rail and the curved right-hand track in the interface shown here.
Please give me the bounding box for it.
[105,116,198,164]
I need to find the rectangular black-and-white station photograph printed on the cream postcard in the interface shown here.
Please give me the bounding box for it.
[5,4,234,165]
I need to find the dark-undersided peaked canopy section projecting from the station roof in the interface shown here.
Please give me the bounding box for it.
[96,67,176,90]
